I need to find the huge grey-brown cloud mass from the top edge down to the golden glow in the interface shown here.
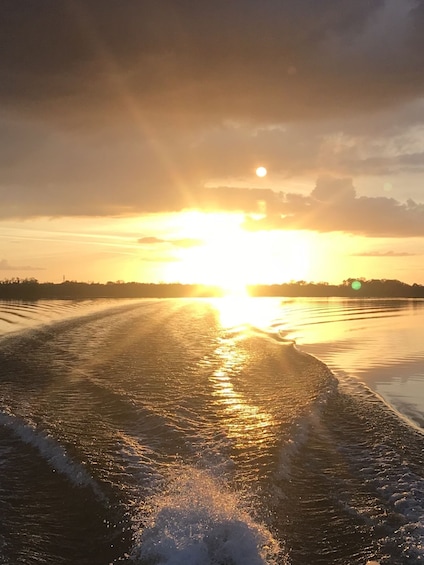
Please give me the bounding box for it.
[0,0,424,219]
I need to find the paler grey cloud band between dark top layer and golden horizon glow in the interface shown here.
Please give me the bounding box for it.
[0,115,424,219]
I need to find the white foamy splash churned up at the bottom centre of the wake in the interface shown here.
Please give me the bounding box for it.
[132,468,285,565]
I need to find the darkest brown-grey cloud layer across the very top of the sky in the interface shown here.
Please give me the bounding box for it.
[0,0,400,125]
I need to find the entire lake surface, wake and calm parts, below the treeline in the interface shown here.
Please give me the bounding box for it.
[0,298,424,565]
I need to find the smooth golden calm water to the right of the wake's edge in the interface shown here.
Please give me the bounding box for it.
[289,299,424,427]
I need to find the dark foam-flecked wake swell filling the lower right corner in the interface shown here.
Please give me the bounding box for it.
[276,370,424,565]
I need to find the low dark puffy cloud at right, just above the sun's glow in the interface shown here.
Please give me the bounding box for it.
[245,178,424,237]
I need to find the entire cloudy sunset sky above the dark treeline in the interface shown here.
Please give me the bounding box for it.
[0,0,424,287]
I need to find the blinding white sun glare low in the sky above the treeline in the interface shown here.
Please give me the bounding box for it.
[167,212,309,296]
